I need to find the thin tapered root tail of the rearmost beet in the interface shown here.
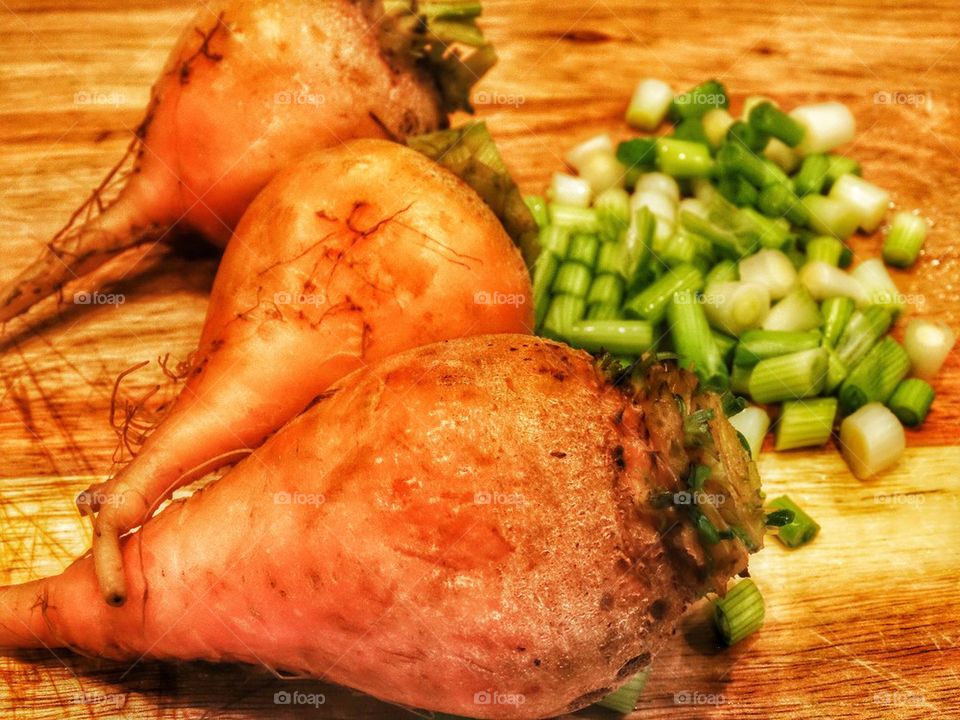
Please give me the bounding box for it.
[0,196,165,325]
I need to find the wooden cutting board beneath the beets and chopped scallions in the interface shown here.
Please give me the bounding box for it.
[0,0,960,719]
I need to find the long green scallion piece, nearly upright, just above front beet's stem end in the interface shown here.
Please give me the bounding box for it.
[667,290,729,390]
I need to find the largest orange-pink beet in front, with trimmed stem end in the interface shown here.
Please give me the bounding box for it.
[0,335,764,718]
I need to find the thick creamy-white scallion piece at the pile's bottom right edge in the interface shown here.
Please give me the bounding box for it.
[840,402,907,480]
